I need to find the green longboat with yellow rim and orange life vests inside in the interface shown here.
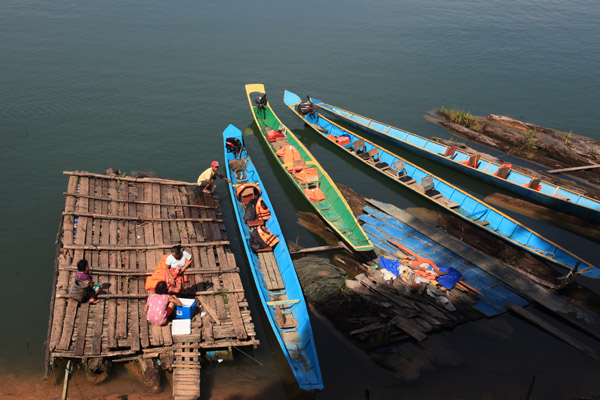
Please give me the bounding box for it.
[246,84,373,251]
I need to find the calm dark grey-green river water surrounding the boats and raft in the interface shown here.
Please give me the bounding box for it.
[0,0,600,399]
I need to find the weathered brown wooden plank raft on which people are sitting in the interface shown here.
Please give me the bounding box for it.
[46,172,259,398]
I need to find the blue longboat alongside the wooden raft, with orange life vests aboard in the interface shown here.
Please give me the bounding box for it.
[223,125,323,390]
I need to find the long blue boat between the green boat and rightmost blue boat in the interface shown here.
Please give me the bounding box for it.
[284,91,600,278]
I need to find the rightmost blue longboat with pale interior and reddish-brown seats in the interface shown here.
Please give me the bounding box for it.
[312,95,600,222]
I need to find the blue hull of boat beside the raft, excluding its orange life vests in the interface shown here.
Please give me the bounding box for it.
[223,125,323,390]
